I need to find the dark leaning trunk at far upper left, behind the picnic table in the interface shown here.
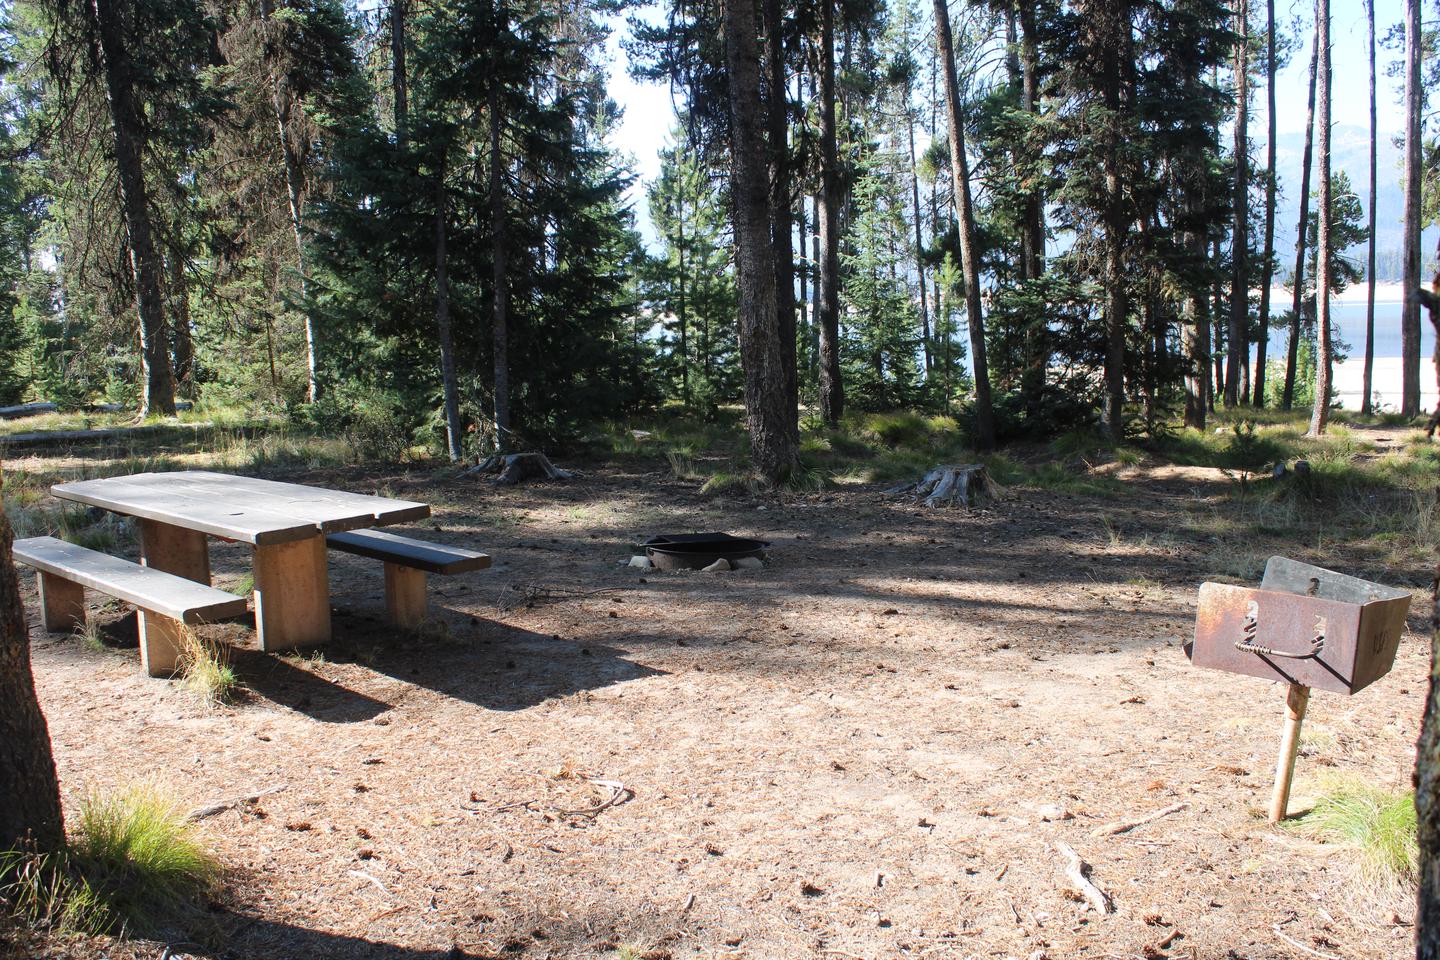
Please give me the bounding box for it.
[89,0,176,416]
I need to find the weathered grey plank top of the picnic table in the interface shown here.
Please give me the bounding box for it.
[50,471,431,545]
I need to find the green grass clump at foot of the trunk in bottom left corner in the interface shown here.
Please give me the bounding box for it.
[0,786,220,936]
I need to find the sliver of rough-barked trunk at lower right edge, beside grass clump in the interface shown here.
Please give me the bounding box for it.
[1414,567,1440,960]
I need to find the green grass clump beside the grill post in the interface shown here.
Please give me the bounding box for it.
[1295,777,1420,894]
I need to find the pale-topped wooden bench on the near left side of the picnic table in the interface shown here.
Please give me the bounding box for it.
[14,537,246,676]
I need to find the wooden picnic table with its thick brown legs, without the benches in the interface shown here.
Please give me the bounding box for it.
[50,471,431,651]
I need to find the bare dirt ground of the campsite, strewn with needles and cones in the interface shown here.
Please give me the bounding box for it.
[5,437,1430,960]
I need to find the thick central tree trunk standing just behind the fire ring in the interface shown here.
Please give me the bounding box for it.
[724,3,799,484]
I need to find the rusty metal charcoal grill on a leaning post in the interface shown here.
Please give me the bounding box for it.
[1185,557,1410,822]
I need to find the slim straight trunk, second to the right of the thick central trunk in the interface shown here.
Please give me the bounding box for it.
[816,3,845,425]
